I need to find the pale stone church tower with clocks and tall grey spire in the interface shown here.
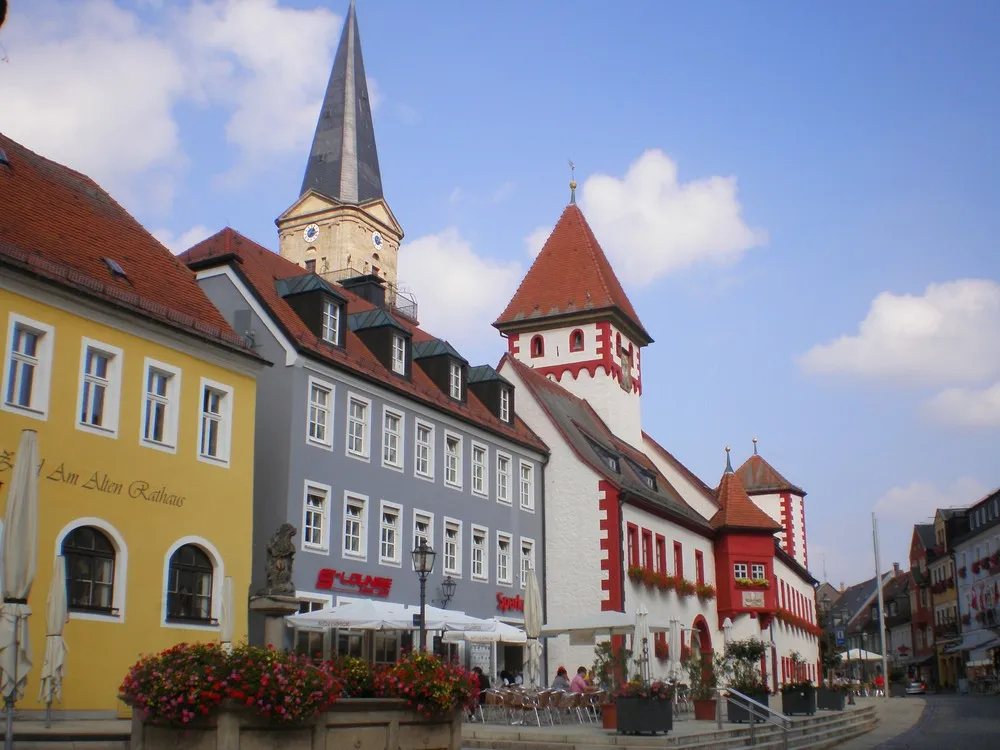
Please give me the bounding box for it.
[275,0,403,288]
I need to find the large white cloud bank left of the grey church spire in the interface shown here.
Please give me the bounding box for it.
[0,0,340,209]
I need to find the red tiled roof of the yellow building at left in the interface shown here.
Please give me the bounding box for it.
[0,134,256,356]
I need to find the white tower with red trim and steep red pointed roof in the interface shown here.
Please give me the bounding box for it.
[493,183,653,445]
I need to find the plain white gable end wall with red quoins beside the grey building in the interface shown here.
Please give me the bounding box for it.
[500,365,606,684]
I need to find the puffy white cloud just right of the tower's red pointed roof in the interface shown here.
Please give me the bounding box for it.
[579,149,767,284]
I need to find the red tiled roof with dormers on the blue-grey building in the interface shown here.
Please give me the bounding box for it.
[180,227,548,453]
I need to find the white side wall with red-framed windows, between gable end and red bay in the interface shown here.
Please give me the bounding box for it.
[622,504,723,677]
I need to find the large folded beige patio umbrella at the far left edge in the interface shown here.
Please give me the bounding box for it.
[0,430,38,750]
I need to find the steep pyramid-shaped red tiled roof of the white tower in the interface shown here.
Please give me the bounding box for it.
[493,203,652,343]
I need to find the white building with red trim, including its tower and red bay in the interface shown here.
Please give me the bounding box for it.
[494,197,820,688]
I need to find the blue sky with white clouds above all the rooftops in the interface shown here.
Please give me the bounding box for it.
[0,0,1000,585]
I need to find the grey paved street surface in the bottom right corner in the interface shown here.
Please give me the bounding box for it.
[838,695,1000,750]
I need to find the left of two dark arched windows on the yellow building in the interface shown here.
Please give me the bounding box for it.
[61,526,115,614]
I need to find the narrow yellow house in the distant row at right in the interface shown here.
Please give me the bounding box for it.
[927,509,968,687]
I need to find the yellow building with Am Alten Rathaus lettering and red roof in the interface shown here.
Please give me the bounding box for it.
[0,135,265,713]
